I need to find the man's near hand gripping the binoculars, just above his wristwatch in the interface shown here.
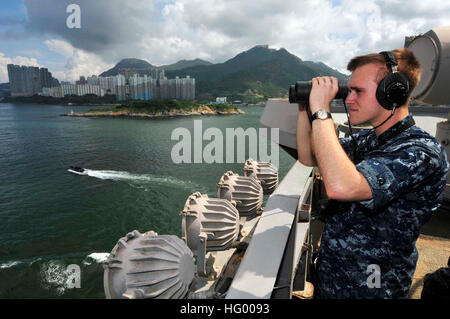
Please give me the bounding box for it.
[309,76,339,114]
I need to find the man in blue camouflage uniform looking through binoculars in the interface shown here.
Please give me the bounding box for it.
[297,48,449,298]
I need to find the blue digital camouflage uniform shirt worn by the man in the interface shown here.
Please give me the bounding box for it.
[316,115,448,298]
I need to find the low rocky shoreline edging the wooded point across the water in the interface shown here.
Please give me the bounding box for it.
[62,106,245,119]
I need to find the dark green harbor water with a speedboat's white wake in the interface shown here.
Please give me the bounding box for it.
[0,104,295,298]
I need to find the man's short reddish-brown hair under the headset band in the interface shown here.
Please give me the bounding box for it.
[347,48,422,92]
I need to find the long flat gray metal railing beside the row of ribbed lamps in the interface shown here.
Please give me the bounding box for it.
[226,162,313,299]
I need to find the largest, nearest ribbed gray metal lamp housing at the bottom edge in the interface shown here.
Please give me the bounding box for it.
[103,230,195,299]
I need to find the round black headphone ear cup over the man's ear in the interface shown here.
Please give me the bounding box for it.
[376,72,409,110]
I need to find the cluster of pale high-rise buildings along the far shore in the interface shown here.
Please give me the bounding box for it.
[8,64,195,101]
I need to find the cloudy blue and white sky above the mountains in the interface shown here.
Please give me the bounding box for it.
[0,0,450,83]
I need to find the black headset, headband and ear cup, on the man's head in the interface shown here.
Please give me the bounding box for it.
[376,51,410,110]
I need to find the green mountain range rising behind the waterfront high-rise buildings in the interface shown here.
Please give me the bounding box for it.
[101,45,347,102]
